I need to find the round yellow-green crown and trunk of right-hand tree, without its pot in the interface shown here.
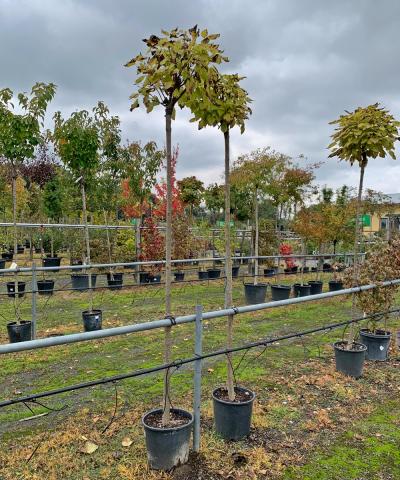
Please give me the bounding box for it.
[328,103,400,349]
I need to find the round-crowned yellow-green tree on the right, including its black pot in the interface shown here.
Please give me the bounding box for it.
[329,103,400,377]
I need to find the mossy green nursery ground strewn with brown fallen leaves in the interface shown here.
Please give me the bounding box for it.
[0,274,400,480]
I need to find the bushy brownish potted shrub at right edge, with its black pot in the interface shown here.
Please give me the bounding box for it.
[345,238,400,361]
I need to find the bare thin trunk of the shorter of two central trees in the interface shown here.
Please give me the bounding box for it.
[224,129,235,401]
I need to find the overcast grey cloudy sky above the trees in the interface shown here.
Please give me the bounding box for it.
[0,0,400,193]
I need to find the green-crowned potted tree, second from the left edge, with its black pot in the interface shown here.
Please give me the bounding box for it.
[53,102,112,331]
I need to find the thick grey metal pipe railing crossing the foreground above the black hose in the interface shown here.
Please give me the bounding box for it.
[0,279,400,354]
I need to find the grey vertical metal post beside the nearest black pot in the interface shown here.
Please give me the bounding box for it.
[193,305,203,452]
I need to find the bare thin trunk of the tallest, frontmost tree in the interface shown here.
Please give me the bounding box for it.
[162,109,172,426]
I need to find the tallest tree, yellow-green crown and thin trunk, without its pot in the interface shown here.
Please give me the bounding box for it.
[126,25,227,426]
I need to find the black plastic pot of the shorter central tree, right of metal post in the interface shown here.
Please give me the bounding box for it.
[213,387,256,440]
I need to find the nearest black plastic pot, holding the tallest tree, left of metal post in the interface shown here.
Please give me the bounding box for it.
[142,408,193,470]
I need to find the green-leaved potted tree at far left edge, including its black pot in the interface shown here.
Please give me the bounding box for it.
[0,83,56,342]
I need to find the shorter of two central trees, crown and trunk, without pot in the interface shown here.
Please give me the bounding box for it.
[190,74,251,401]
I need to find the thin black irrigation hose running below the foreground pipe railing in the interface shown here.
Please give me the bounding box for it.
[0,308,400,408]
